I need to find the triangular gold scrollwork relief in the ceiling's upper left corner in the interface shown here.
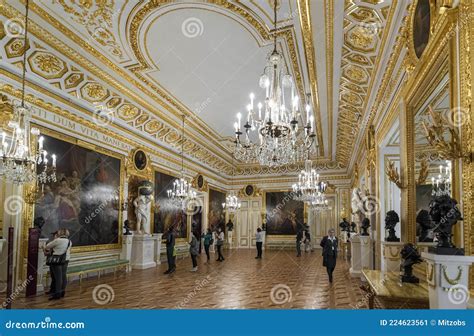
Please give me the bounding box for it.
[53,0,123,59]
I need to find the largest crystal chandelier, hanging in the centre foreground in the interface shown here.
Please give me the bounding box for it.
[234,0,315,167]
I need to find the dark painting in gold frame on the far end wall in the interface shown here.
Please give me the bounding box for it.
[265,192,304,235]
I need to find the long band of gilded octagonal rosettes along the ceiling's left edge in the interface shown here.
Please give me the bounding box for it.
[0,10,230,176]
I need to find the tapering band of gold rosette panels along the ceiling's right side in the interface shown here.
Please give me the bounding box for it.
[336,0,397,166]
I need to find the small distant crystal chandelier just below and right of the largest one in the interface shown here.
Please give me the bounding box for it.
[293,159,327,204]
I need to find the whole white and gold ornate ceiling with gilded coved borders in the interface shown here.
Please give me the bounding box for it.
[0,0,407,180]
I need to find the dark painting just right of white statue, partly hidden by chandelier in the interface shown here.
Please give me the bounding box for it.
[154,171,188,238]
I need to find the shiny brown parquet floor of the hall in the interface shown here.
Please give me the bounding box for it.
[13,250,367,309]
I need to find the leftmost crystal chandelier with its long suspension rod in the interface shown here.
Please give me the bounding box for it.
[0,1,56,185]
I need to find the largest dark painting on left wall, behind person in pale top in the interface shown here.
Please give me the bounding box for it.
[34,135,121,247]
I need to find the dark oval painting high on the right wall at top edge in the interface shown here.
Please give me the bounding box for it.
[413,0,430,58]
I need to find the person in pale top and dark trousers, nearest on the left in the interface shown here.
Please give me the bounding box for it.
[46,229,72,300]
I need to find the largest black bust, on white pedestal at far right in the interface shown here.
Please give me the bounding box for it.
[430,195,464,255]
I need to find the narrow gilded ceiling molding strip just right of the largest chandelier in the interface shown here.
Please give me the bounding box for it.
[298,0,326,156]
